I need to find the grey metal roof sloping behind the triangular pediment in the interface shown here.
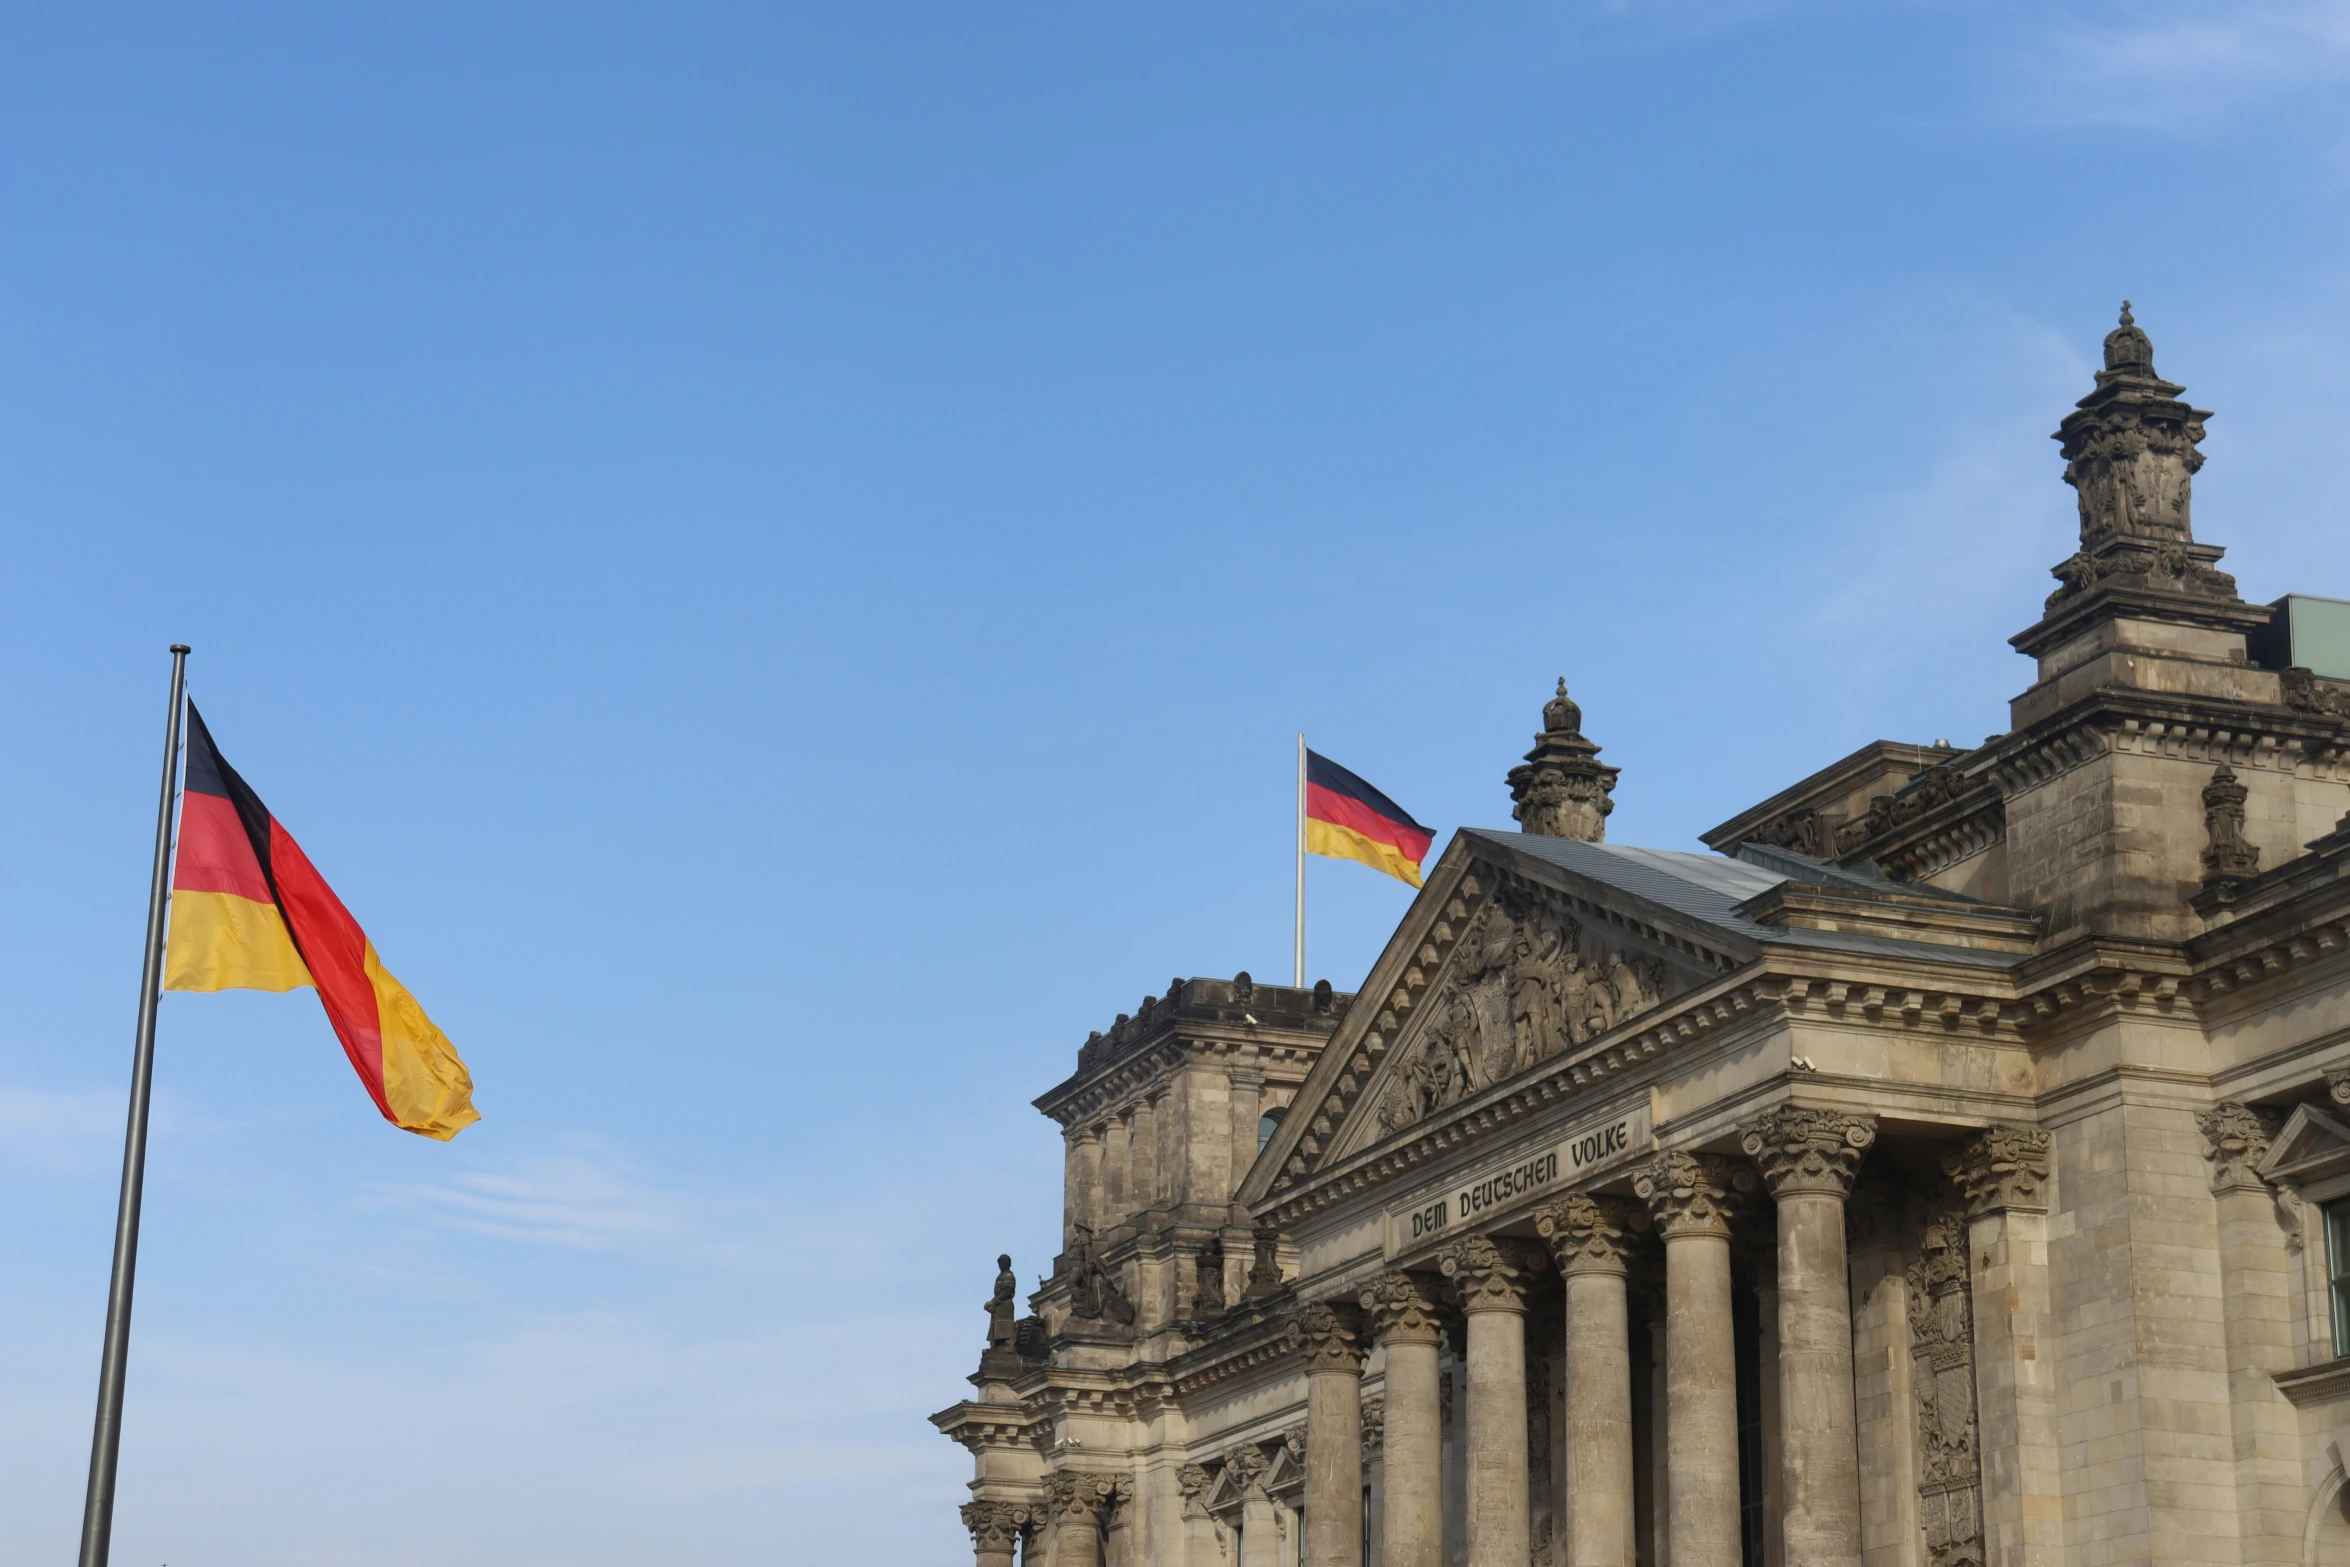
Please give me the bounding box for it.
[1462,827,2023,968]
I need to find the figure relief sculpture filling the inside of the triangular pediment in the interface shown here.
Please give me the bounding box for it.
[1377,888,1683,1132]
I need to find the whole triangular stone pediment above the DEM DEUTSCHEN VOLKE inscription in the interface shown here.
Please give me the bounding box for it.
[1238,832,1760,1203]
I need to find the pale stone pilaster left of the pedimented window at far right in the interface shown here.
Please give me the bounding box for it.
[2195,1102,2303,1562]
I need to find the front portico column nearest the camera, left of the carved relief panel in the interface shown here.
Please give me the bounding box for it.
[1739,1104,1878,1567]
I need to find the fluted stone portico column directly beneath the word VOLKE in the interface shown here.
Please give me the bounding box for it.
[1535,1193,1647,1567]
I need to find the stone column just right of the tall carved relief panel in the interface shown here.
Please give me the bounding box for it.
[1941,1125,2063,1567]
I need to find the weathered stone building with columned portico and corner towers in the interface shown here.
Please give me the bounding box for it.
[933,310,2350,1567]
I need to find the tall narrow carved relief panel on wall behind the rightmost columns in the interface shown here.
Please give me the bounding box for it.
[1906,1210,1983,1567]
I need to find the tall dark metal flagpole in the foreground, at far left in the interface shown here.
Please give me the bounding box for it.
[82,641,188,1567]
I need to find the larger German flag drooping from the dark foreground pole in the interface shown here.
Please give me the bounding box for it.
[162,702,482,1142]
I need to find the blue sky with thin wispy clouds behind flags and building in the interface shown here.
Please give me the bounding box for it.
[0,0,2350,1567]
